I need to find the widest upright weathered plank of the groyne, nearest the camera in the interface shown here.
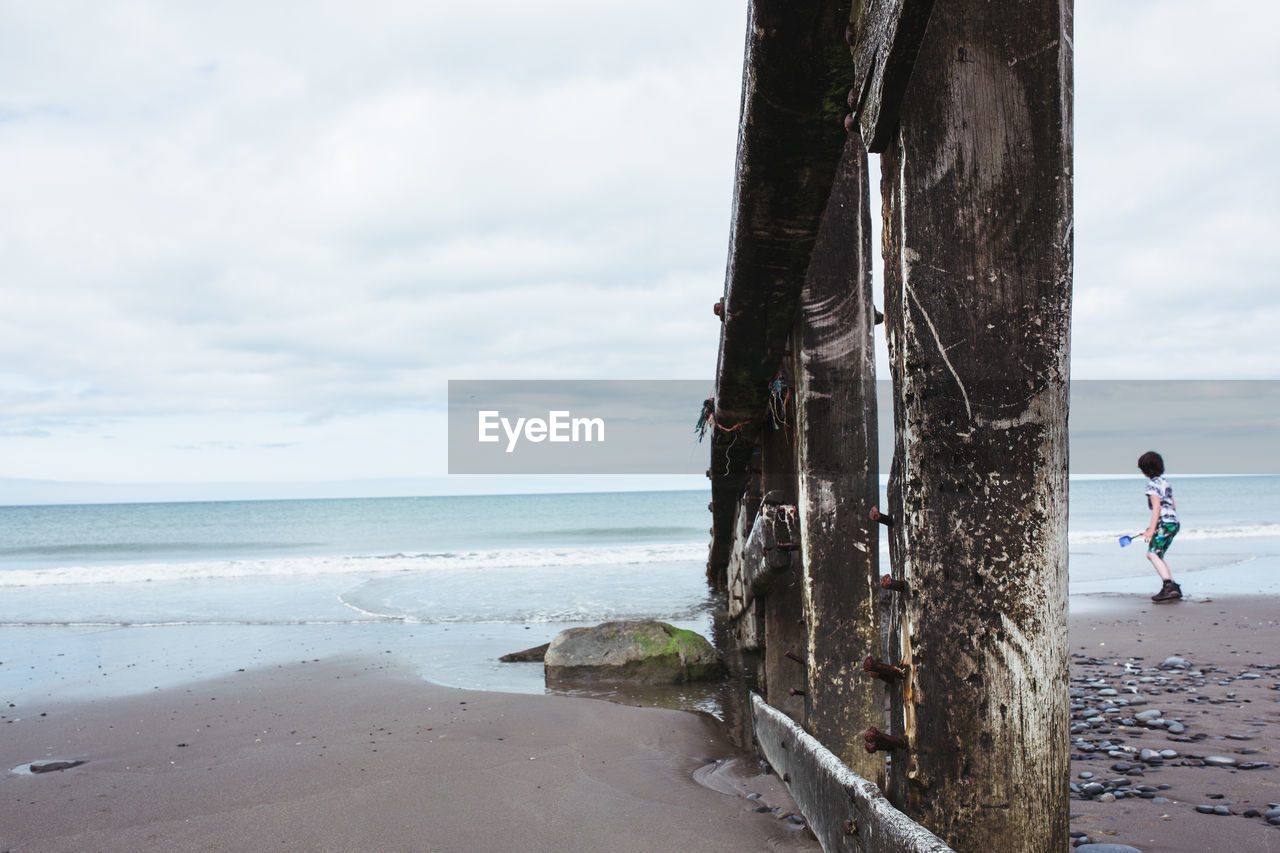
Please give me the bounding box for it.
[882,0,1071,850]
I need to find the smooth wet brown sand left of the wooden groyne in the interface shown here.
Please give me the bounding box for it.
[0,657,818,853]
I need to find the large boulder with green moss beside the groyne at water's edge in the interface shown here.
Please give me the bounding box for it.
[544,621,723,684]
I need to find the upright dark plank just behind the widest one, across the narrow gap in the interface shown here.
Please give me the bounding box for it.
[795,128,884,780]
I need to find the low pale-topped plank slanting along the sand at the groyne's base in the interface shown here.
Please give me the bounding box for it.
[751,694,957,853]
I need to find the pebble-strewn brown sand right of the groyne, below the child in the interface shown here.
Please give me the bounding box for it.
[1071,591,1280,853]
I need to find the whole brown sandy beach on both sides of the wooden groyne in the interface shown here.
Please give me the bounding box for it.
[0,596,1280,853]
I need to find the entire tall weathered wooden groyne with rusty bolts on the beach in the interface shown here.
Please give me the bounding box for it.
[708,0,1073,853]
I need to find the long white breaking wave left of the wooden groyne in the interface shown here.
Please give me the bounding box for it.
[0,543,707,588]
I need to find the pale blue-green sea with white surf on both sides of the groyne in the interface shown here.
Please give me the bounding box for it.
[0,476,1280,710]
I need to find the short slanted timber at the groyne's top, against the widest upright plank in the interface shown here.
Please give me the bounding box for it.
[849,0,933,154]
